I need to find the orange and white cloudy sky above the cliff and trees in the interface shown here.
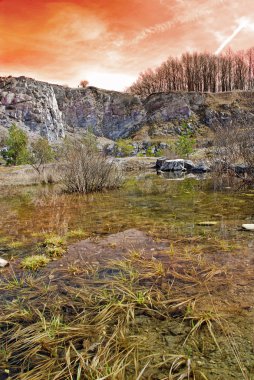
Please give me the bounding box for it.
[0,0,254,90]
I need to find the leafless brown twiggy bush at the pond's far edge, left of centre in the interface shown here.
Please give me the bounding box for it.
[63,141,121,193]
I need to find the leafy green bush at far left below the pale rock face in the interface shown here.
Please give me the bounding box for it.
[1,124,29,165]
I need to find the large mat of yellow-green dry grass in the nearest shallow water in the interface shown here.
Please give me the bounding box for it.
[0,251,250,380]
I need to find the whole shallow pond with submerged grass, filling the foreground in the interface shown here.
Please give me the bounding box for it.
[0,173,254,380]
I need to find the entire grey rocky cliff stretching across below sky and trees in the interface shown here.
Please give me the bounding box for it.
[0,77,254,141]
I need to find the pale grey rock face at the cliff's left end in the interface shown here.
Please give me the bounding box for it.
[0,77,65,141]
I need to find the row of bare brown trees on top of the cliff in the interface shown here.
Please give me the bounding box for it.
[126,47,254,97]
